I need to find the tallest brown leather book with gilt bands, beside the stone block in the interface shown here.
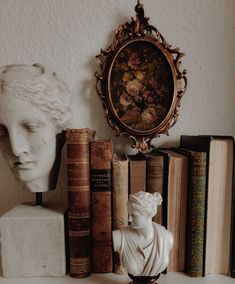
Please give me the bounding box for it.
[66,128,95,278]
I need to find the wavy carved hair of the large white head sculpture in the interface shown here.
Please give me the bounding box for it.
[0,64,71,133]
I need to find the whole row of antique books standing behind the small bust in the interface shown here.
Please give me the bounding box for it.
[66,129,235,277]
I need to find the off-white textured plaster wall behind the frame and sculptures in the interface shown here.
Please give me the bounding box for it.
[0,0,235,214]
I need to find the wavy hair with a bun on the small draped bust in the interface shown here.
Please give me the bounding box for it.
[127,191,162,218]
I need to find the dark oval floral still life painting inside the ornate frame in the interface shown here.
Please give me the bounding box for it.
[110,41,174,131]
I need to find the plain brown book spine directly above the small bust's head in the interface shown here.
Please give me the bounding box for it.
[128,153,146,194]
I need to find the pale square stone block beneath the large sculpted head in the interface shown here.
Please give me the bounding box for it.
[0,204,66,277]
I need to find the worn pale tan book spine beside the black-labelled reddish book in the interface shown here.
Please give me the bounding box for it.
[112,154,128,274]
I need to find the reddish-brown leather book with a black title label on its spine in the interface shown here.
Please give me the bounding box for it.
[90,140,113,273]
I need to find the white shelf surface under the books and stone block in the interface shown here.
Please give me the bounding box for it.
[0,272,232,284]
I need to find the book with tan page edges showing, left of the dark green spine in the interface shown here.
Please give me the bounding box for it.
[155,148,188,272]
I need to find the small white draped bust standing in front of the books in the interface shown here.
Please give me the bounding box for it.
[113,191,173,283]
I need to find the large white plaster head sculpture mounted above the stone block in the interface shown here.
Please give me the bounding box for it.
[0,64,71,192]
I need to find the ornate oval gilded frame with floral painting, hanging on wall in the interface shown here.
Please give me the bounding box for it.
[95,2,187,152]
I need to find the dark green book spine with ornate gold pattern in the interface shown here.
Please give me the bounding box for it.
[185,152,207,277]
